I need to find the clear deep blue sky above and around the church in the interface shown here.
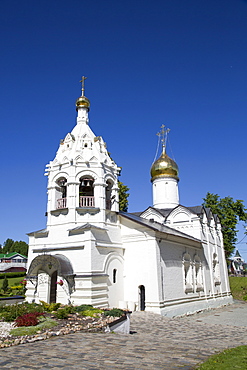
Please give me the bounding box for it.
[0,0,247,260]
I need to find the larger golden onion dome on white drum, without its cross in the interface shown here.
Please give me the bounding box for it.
[150,151,179,181]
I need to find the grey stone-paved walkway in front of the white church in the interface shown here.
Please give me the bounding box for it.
[0,302,247,370]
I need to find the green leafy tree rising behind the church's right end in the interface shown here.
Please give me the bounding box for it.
[203,193,247,258]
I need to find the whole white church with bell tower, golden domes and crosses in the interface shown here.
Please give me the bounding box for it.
[27,78,232,316]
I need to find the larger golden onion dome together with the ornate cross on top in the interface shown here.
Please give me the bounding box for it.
[150,125,179,182]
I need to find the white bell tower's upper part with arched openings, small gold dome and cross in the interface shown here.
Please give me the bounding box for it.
[45,76,120,228]
